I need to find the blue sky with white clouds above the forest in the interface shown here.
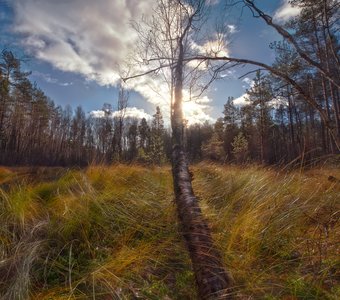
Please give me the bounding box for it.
[0,0,297,123]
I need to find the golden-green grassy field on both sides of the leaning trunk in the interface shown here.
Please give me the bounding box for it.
[0,163,340,300]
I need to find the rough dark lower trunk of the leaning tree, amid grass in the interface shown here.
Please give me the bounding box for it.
[172,145,231,300]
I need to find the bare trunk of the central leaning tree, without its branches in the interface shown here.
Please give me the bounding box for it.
[171,15,231,300]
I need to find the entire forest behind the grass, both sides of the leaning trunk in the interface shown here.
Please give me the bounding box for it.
[0,0,340,165]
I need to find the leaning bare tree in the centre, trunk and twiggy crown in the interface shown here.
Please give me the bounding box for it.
[124,0,231,299]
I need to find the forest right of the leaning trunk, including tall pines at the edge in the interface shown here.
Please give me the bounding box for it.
[204,0,340,164]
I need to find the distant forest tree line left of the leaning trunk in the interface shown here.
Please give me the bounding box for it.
[0,50,170,166]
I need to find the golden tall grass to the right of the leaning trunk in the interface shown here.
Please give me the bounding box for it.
[194,165,340,299]
